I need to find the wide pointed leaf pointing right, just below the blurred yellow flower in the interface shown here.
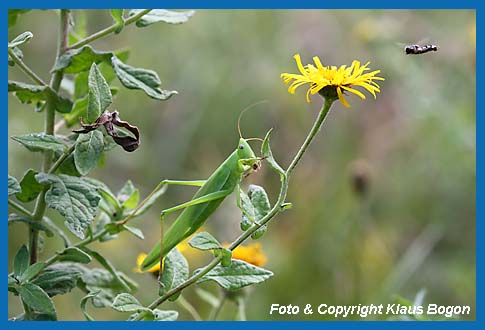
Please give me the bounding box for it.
[194,259,273,290]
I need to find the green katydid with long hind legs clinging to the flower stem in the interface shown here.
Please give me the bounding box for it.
[118,102,262,271]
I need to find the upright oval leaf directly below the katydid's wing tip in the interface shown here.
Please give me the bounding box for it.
[159,248,189,301]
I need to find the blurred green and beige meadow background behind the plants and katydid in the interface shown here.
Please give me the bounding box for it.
[8,10,476,320]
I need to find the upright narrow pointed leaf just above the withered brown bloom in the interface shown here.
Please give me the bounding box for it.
[87,63,113,123]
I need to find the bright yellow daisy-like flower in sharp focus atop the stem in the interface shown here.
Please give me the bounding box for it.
[281,54,384,108]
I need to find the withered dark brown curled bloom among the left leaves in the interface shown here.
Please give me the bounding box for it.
[73,111,140,152]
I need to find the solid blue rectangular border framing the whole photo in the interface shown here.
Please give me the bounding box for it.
[0,0,478,329]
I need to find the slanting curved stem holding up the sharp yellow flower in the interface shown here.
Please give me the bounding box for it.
[133,99,335,321]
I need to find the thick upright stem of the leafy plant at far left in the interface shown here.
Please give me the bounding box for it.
[29,9,69,264]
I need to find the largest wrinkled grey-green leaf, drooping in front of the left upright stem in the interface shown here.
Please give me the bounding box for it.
[35,173,100,239]
